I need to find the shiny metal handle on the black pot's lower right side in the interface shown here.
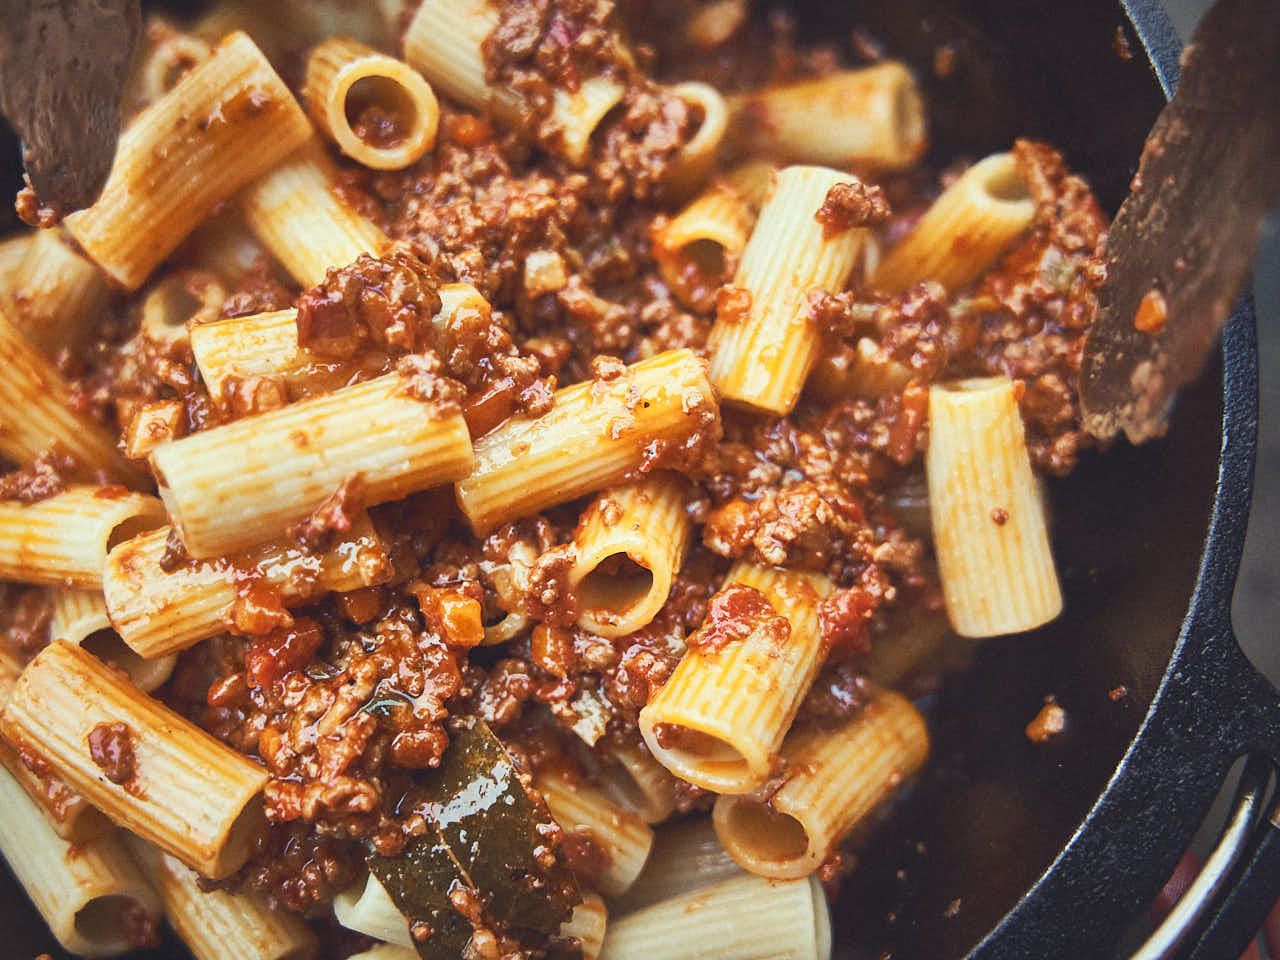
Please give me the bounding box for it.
[1133,754,1280,960]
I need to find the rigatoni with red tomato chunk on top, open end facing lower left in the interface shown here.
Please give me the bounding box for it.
[640,562,832,794]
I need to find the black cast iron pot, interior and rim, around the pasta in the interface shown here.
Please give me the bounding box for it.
[0,0,1280,960]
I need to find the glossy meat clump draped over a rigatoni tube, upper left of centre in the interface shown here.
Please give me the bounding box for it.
[298,253,440,360]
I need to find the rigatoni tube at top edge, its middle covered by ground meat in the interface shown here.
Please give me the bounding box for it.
[404,0,625,164]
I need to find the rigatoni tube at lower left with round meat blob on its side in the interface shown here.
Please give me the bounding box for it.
[0,640,266,878]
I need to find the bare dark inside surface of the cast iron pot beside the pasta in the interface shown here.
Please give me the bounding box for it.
[0,0,1221,960]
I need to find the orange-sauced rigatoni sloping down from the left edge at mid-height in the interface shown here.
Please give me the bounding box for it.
[0,311,133,480]
